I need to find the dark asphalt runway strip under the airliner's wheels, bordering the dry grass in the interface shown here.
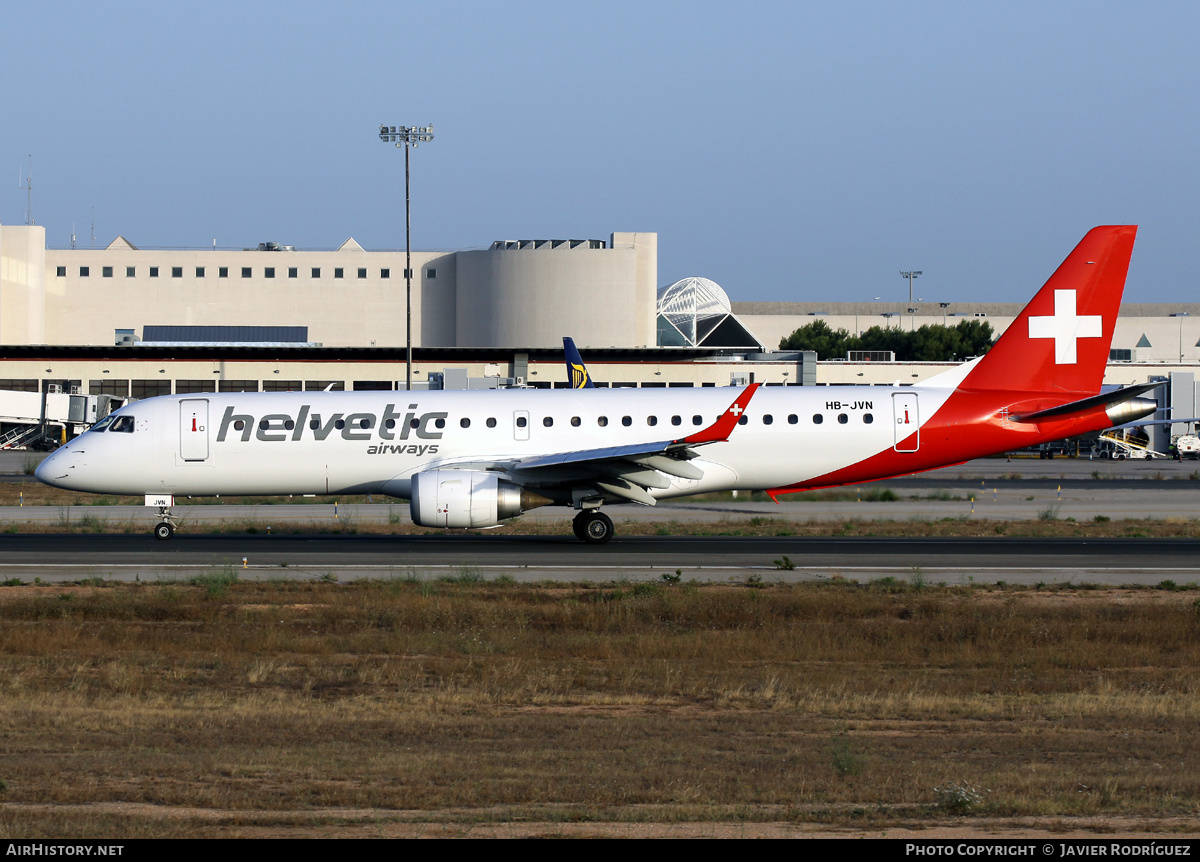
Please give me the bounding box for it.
[0,534,1200,585]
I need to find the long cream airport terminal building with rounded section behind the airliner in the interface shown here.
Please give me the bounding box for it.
[0,219,1200,451]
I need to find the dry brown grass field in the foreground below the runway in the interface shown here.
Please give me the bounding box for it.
[0,571,1200,838]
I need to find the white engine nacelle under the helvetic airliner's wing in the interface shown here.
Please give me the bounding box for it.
[409,469,551,527]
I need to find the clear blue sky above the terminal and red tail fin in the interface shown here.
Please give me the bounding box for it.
[0,0,1200,303]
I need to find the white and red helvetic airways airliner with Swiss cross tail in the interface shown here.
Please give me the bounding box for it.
[37,226,1157,543]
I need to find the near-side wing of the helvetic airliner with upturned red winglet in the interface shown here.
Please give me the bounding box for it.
[505,383,761,505]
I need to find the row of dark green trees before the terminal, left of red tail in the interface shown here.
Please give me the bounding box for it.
[779,319,992,363]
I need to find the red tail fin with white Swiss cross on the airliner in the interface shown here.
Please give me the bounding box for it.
[960,225,1138,394]
